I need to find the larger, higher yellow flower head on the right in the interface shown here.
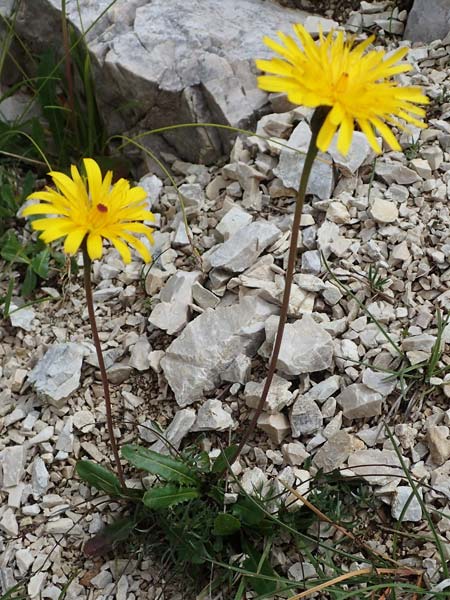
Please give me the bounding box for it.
[256,24,428,155]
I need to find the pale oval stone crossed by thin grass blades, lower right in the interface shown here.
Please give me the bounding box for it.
[348,448,409,485]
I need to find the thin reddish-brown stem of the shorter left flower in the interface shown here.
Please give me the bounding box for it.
[82,241,126,489]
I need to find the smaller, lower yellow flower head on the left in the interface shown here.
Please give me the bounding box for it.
[22,158,154,263]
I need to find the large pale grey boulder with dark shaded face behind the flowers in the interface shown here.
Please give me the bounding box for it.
[6,0,307,162]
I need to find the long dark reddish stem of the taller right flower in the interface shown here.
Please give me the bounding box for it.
[227,107,328,468]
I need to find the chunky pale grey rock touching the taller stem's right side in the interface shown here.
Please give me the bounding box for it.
[267,315,333,375]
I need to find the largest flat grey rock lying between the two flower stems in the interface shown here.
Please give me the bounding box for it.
[161,298,277,406]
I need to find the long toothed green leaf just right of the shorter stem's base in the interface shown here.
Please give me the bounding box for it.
[122,445,199,485]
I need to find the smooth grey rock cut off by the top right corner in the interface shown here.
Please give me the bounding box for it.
[403,0,450,42]
